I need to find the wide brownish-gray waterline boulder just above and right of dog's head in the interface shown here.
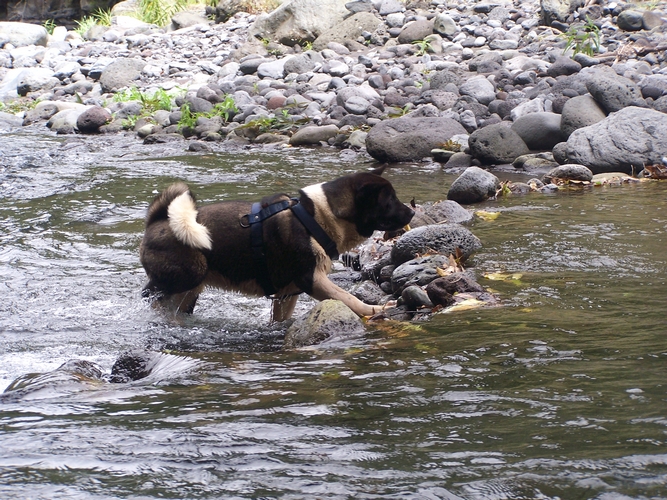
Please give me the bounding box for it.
[366,117,466,162]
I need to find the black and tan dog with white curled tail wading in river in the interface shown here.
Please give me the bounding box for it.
[140,167,414,321]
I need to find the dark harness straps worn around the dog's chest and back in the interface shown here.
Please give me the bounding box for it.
[239,198,338,297]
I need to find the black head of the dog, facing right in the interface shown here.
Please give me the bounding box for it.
[322,167,414,237]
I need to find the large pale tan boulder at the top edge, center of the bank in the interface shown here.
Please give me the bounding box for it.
[249,0,348,47]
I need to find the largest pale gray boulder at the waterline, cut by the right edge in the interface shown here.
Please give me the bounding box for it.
[567,106,667,174]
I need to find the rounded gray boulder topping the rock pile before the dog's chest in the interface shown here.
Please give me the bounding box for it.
[391,224,482,265]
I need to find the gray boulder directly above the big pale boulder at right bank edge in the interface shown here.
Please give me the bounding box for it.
[586,66,646,113]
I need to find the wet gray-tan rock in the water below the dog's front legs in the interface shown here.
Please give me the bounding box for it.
[284,300,366,349]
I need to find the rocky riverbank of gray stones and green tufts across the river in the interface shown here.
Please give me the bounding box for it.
[0,0,667,174]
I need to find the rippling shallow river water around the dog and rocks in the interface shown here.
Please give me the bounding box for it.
[0,133,667,500]
